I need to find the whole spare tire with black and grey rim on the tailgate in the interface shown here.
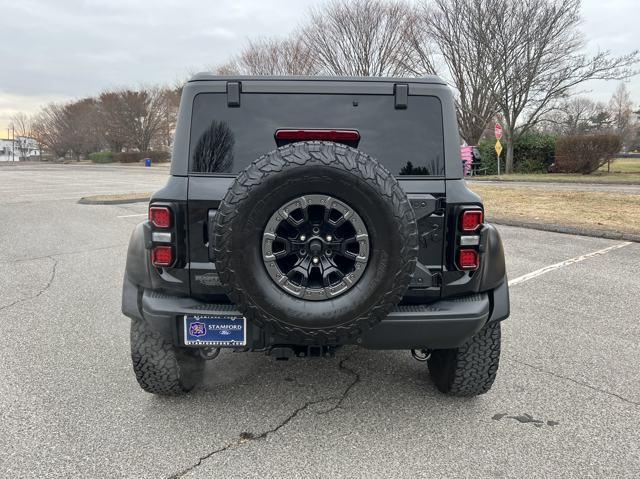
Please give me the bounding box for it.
[213,142,418,344]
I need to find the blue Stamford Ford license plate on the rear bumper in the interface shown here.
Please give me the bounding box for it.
[184,315,247,346]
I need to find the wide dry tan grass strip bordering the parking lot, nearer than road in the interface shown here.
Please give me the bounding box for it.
[468,183,640,234]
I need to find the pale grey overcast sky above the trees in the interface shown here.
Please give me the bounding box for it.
[0,0,640,137]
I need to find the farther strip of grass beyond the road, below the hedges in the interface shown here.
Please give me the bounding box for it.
[473,158,640,184]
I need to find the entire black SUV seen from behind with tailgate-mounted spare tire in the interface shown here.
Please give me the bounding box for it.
[122,74,509,396]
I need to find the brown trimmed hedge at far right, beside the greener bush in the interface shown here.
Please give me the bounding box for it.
[554,134,622,175]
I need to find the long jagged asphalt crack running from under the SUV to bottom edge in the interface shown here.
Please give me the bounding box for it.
[167,352,361,479]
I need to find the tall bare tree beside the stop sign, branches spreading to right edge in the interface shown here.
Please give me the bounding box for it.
[472,0,637,172]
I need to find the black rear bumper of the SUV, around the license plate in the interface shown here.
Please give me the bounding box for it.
[122,276,509,349]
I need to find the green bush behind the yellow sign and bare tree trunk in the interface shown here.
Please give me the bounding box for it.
[478,133,556,175]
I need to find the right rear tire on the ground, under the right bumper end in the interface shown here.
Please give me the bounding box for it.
[428,321,500,397]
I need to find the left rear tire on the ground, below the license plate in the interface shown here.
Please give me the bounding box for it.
[131,320,204,396]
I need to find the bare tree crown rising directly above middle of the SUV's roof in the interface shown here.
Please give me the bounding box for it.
[301,0,422,76]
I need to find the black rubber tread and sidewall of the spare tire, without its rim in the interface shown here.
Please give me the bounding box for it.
[213,141,418,344]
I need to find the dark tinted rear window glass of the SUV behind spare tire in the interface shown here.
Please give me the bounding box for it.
[190,93,444,176]
